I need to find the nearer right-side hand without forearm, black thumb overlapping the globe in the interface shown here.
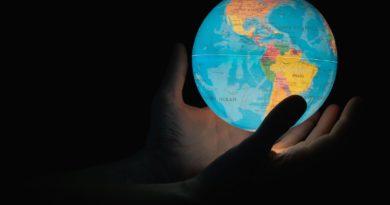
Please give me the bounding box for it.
[187,96,363,201]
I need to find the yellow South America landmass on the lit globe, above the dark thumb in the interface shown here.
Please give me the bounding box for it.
[267,49,318,113]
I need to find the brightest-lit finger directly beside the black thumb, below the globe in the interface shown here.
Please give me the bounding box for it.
[272,112,321,153]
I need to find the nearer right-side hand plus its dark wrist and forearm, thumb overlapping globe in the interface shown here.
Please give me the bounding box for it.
[126,96,362,204]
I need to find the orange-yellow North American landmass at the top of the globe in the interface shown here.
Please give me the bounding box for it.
[226,0,280,38]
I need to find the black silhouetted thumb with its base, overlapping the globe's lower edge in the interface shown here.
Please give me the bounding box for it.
[198,96,306,190]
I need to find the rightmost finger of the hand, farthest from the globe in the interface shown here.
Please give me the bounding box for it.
[330,97,363,135]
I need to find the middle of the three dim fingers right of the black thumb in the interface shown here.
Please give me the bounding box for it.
[306,105,340,142]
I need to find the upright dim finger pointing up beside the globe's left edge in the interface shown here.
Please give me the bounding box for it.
[161,44,188,103]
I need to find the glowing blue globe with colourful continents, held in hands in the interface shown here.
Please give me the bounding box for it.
[192,0,337,131]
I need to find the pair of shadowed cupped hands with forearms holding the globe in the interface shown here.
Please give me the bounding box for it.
[30,44,362,204]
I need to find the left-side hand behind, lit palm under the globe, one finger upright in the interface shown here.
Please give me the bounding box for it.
[144,44,251,182]
